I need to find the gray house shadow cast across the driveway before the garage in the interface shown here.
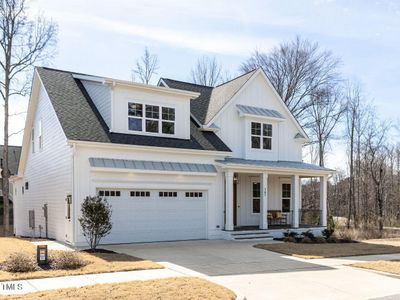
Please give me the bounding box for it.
[102,240,332,276]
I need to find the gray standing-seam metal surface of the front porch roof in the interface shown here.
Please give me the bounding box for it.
[216,157,335,172]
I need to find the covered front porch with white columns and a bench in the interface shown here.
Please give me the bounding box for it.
[219,160,332,235]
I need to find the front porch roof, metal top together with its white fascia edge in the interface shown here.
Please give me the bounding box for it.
[216,157,335,174]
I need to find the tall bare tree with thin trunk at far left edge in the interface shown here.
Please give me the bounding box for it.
[0,0,57,234]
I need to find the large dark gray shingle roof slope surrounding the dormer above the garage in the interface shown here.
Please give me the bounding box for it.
[37,67,230,151]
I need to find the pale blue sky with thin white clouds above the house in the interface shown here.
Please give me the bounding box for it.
[3,0,400,169]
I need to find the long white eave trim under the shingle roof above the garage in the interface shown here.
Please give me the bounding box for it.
[68,140,232,157]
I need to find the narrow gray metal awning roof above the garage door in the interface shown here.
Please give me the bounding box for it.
[89,157,217,173]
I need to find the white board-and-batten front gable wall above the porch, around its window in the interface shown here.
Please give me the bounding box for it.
[214,73,302,161]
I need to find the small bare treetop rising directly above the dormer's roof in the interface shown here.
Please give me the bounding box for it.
[132,47,160,84]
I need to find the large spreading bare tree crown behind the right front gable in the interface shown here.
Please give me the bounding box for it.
[241,36,340,122]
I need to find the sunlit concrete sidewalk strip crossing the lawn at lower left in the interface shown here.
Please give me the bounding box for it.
[0,268,185,295]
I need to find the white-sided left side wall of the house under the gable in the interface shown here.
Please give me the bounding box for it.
[14,86,72,241]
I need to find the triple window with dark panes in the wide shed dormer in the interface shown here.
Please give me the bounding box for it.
[128,102,175,134]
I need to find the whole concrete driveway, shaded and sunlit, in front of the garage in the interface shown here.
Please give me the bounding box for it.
[105,241,400,300]
